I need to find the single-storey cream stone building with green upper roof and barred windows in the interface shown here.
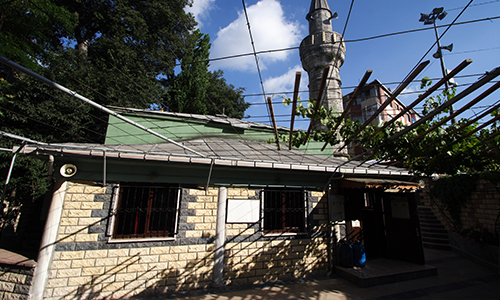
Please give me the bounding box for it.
[21,109,421,299]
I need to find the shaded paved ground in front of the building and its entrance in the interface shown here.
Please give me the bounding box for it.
[133,249,500,300]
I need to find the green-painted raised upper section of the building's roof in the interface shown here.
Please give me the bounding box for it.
[105,107,333,155]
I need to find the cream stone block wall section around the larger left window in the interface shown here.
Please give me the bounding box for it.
[45,182,217,299]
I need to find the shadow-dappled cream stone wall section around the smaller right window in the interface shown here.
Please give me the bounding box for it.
[224,189,328,284]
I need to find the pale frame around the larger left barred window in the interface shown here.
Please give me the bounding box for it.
[106,182,182,243]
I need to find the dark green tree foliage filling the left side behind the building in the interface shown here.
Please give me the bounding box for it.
[0,0,248,253]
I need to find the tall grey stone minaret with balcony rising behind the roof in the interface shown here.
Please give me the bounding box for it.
[300,0,345,129]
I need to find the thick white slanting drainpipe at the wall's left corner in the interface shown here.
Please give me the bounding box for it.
[30,179,68,300]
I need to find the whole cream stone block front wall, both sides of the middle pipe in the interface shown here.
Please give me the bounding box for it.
[44,182,328,299]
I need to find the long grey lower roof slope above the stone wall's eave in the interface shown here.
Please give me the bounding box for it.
[17,138,409,175]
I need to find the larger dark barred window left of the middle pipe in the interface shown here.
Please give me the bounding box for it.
[113,185,179,238]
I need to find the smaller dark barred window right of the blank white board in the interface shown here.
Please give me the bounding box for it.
[262,189,306,233]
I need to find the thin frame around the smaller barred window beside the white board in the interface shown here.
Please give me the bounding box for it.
[260,188,309,236]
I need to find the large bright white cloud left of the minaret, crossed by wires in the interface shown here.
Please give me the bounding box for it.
[211,0,301,71]
